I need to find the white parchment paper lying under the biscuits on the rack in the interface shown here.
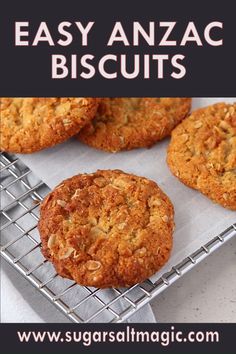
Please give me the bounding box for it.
[18,97,236,280]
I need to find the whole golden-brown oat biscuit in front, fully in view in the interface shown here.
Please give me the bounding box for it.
[38,170,174,288]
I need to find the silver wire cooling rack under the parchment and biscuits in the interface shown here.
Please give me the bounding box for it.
[0,153,236,323]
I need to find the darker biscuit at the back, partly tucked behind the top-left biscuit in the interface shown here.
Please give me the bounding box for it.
[78,98,191,152]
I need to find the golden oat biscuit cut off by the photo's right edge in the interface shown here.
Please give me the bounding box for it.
[167,103,236,210]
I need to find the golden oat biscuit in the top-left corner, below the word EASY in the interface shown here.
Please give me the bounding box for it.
[0,97,98,153]
